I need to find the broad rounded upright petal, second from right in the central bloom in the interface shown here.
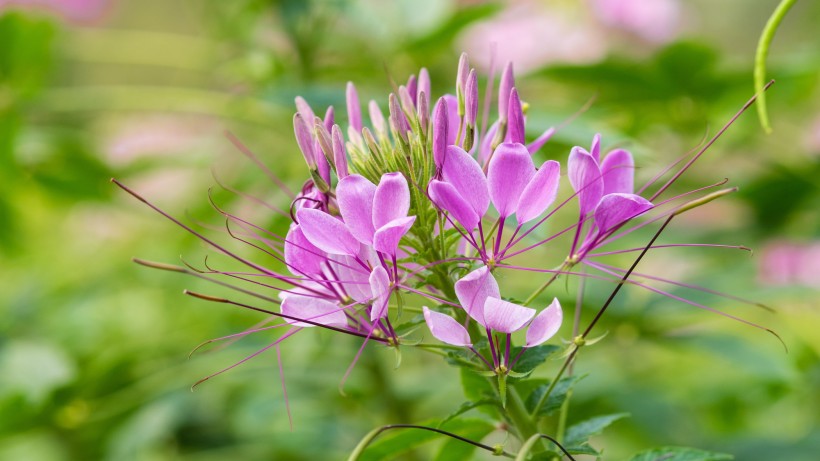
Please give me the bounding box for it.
[487,143,535,218]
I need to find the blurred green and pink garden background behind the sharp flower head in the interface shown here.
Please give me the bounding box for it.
[0,0,820,461]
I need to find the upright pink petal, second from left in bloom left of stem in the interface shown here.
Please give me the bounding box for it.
[336,174,376,245]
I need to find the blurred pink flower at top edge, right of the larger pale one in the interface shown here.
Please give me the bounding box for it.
[589,0,682,43]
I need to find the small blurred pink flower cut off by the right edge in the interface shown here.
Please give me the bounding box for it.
[758,241,820,287]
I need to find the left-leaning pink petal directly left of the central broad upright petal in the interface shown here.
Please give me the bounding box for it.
[441,146,490,218]
